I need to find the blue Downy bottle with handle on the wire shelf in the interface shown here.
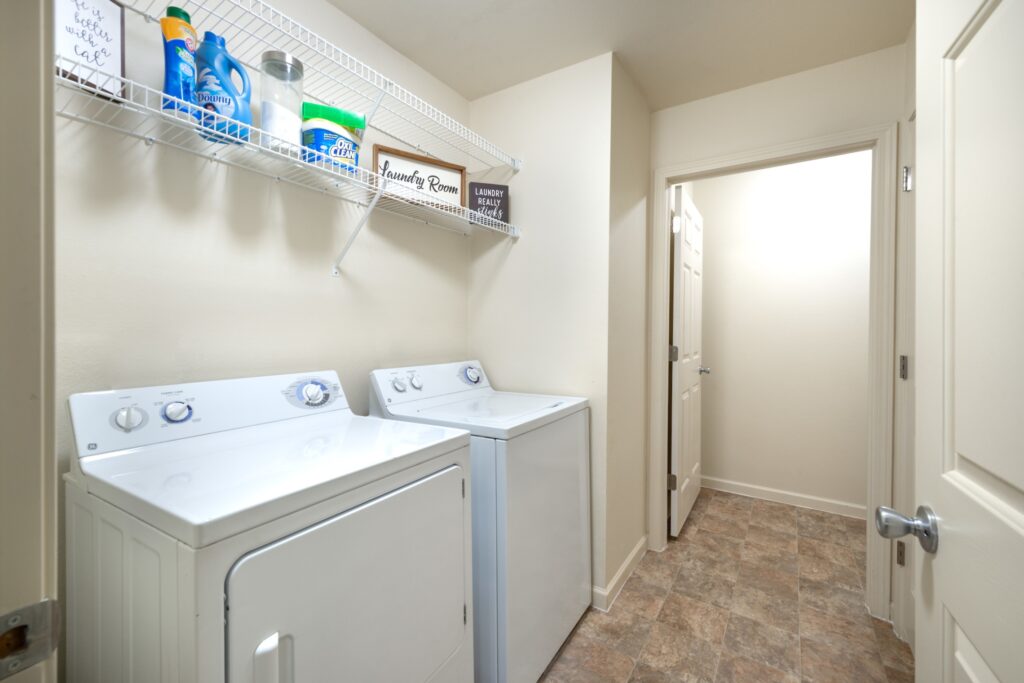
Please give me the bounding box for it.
[196,31,253,142]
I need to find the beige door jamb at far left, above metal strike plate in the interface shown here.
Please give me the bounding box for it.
[0,0,59,683]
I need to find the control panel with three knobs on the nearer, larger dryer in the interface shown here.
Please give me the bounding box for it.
[68,371,348,458]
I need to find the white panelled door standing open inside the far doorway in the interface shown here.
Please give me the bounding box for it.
[669,185,703,536]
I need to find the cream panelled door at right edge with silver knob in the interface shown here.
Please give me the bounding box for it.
[917,0,1024,683]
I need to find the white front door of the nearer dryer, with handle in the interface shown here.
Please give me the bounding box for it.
[225,466,472,683]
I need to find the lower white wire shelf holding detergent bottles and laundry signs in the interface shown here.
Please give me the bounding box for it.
[54,55,519,269]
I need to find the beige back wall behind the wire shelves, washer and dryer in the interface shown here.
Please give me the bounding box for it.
[56,0,477,459]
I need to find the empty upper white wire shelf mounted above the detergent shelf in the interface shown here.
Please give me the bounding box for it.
[122,0,521,173]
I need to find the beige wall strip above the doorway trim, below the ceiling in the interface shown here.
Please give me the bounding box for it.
[651,45,904,168]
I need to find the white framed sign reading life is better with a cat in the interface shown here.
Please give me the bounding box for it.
[53,0,125,95]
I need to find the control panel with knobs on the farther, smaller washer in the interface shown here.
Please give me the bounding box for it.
[370,360,490,405]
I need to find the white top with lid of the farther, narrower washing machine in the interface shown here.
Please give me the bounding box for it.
[391,390,587,439]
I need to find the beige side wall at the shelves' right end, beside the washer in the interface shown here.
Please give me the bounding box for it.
[468,54,612,587]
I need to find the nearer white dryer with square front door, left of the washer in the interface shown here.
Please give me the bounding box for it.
[67,372,473,683]
